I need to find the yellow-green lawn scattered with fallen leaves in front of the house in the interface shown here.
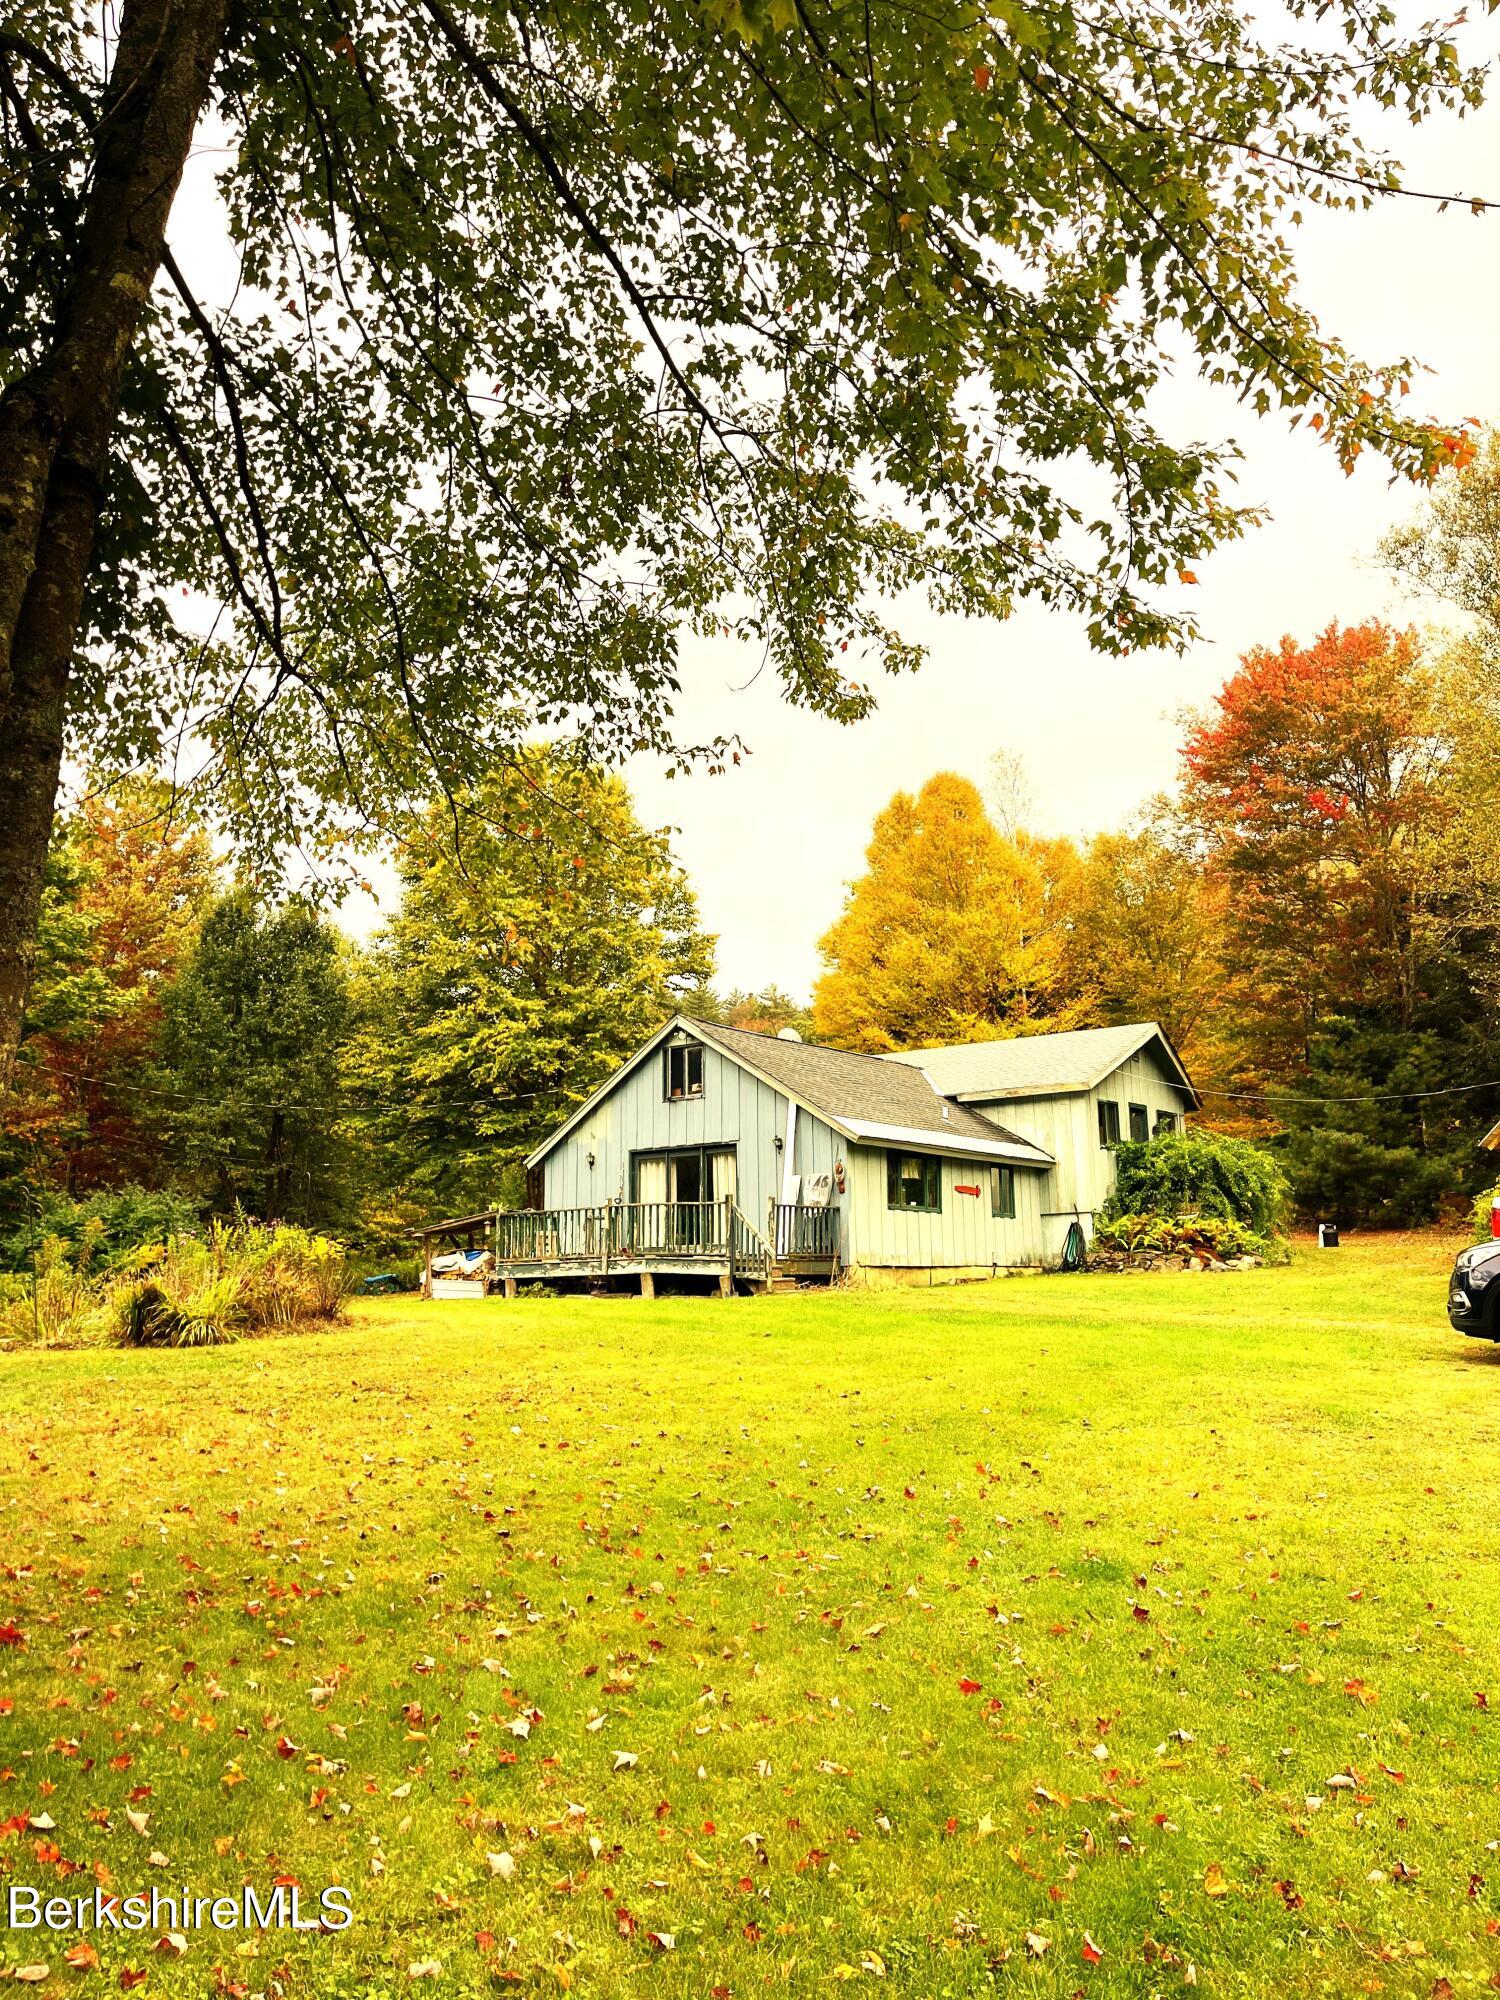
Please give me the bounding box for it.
[0,1238,1500,2000]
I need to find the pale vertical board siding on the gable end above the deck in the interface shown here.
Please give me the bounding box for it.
[542,1042,848,1262]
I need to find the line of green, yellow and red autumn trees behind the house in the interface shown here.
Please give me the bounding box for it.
[0,440,1500,1246]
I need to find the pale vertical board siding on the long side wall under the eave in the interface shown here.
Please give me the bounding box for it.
[848,1146,1044,1270]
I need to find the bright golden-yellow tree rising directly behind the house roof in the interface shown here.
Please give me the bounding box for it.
[812,772,1082,1054]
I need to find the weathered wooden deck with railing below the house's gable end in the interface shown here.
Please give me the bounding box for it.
[418,1202,838,1298]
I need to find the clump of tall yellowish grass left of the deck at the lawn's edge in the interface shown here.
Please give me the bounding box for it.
[0,1222,350,1348]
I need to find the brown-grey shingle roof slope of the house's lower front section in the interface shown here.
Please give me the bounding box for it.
[686,1020,1050,1166]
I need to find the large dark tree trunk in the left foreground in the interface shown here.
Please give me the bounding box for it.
[0,0,228,1092]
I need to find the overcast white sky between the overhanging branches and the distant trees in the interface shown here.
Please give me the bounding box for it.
[172,30,1500,994]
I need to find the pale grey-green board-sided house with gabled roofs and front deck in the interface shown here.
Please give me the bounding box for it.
[446,1014,1198,1290]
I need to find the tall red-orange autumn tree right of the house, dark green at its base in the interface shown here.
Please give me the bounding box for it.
[1182,622,1496,1218]
